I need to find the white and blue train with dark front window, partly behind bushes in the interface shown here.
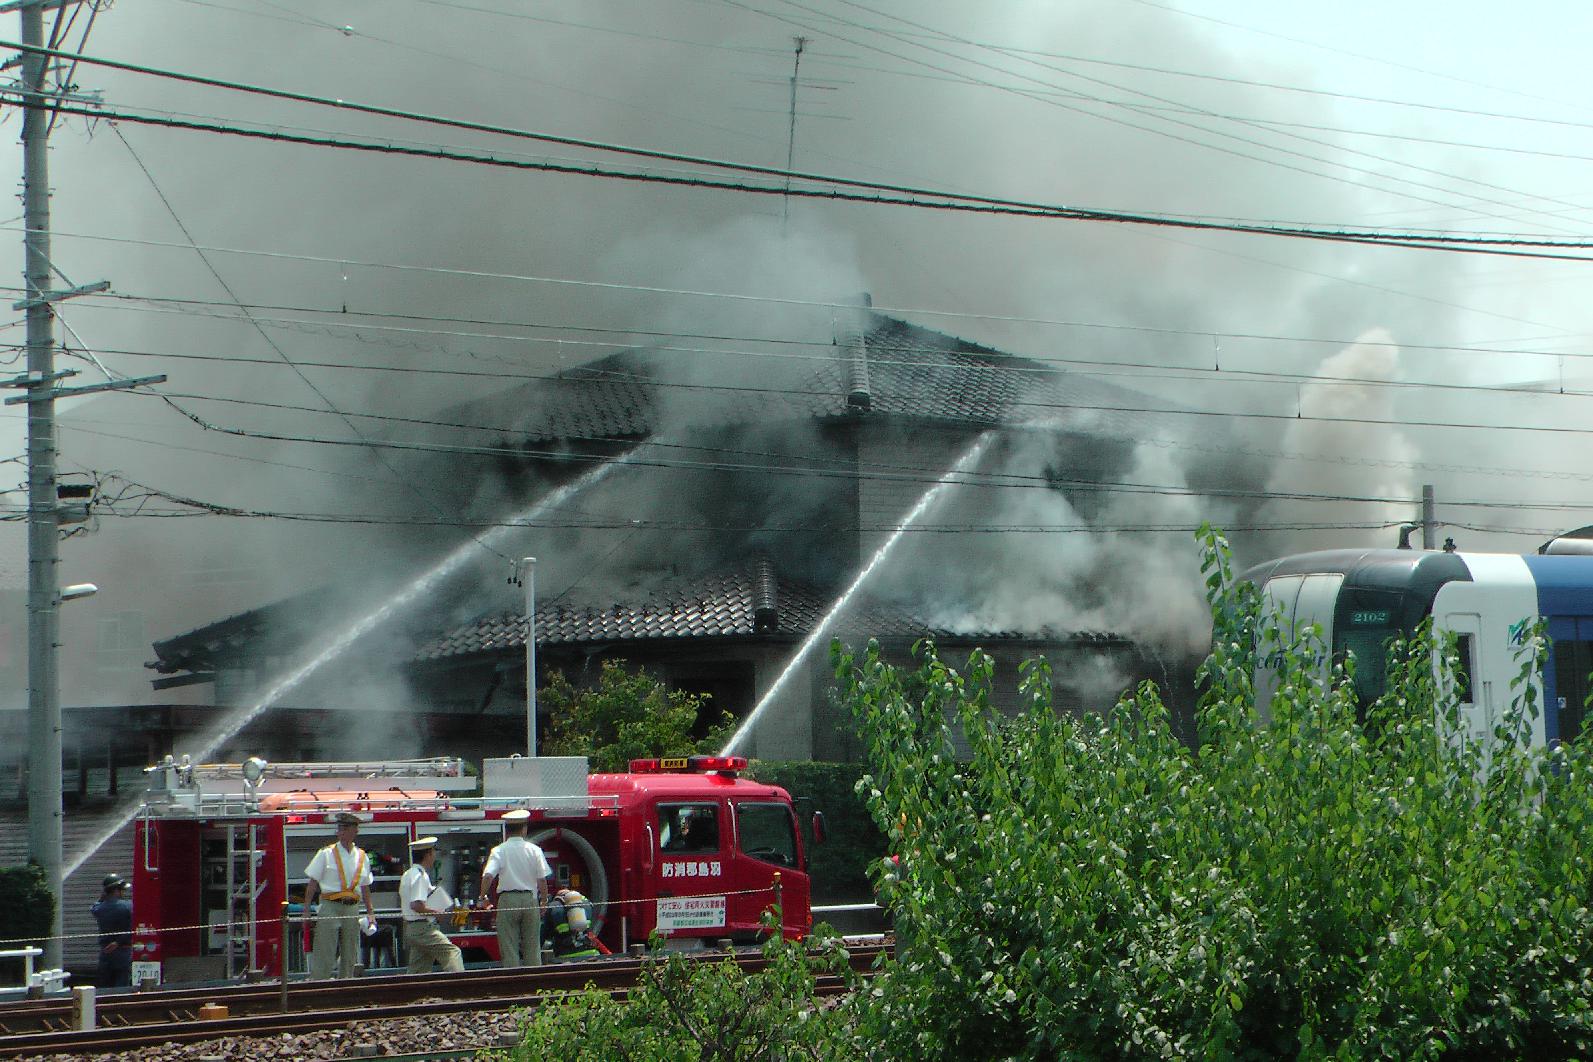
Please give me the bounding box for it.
[1239,532,1593,747]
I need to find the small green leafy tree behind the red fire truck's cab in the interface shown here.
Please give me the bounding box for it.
[537,661,731,771]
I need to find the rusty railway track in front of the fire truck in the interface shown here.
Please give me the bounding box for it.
[0,947,881,1057]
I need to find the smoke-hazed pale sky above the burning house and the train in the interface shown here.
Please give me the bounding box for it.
[0,0,1593,713]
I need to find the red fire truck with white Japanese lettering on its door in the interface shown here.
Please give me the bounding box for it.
[132,756,824,984]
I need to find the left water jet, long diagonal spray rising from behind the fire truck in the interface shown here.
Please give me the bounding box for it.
[64,457,626,877]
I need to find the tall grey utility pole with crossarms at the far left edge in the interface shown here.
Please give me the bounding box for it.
[0,10,166,968]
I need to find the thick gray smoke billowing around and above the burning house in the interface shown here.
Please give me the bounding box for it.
[0,0,1582,722]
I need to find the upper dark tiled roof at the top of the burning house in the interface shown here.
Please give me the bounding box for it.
[454,310,1161,443]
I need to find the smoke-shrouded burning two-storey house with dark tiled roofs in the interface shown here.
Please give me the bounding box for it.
[150,307,1203,759]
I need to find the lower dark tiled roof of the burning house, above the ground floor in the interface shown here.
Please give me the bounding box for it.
[416,562,1128,661]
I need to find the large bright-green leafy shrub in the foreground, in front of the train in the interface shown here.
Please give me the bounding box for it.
[838,535,1593,1059]
